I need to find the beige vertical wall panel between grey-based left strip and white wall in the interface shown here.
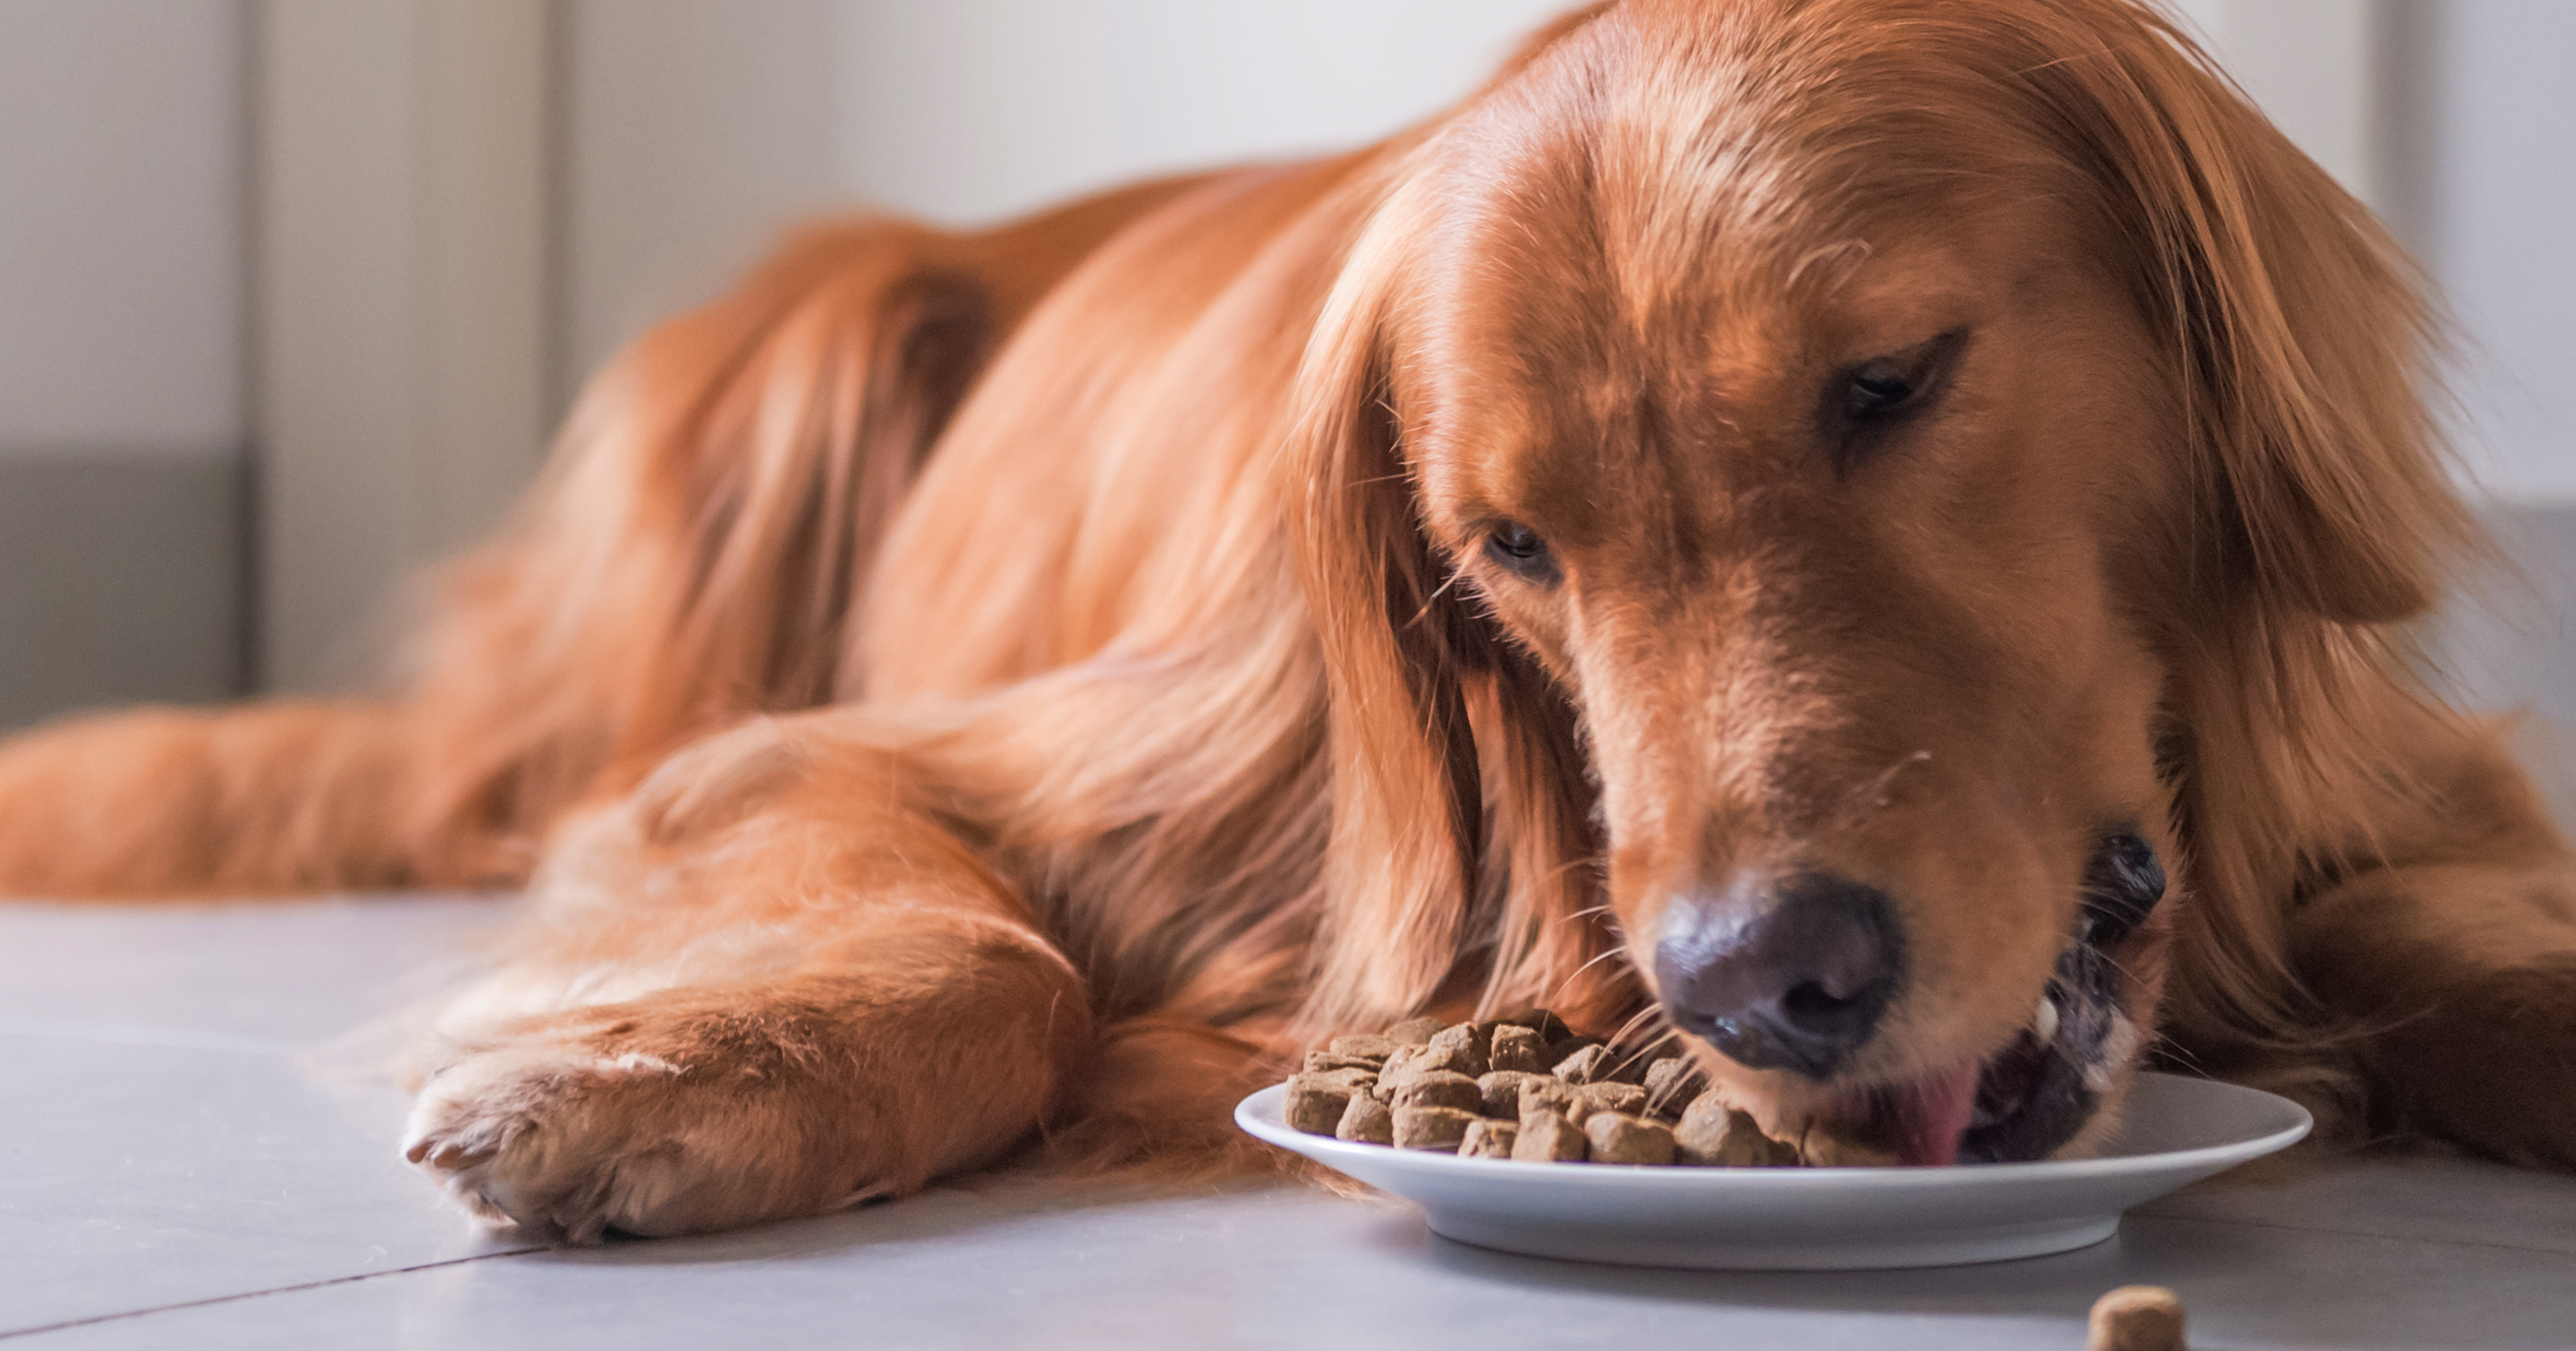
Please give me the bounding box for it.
[252,0,554,691]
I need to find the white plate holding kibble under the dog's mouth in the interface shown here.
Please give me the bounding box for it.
[1234,1075,2310,1271]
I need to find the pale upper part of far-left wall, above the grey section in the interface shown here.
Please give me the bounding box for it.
[0,0,245,456]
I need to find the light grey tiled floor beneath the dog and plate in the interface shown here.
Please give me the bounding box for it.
[0,897,2576,1351]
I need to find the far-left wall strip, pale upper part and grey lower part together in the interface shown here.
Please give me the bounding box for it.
[0,0,250,727]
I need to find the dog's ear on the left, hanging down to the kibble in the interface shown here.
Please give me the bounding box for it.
[1285,206,1621,1029]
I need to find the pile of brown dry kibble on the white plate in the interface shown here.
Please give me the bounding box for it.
[1288,1011,1803,1165]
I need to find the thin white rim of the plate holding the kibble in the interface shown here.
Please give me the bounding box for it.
[1234,1070,2316,1191]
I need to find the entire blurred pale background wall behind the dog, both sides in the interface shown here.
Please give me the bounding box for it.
[0,0,2576,727]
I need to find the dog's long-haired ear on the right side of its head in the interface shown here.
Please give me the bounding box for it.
[2028,0,2473,624]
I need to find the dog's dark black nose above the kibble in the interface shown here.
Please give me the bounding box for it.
[1654,871,1901,1078]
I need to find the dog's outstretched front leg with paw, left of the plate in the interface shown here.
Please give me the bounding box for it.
[404,714,1092,1243]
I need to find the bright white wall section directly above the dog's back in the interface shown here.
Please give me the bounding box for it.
[564,0,1569,389]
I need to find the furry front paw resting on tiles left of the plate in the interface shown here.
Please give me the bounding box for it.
[402,1034,852,1243]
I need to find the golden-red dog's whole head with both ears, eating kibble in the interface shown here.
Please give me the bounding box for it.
[1296,0,2450,1160]
